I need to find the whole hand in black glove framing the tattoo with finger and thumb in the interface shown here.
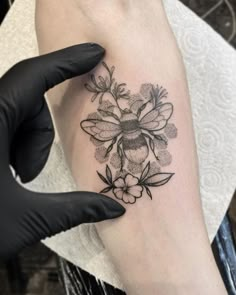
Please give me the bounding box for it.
[0,43,125,259]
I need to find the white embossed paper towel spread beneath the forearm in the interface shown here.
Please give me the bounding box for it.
[0,0,236,288]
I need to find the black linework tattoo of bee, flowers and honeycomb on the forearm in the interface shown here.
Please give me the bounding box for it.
[80,62,177,204]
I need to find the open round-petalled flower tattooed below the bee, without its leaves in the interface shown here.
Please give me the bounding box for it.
[113,174,143,204]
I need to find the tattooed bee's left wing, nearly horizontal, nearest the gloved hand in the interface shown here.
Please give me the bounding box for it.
[80,119,122,141]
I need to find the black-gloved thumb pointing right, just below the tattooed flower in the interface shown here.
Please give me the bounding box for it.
[0,183,125,260]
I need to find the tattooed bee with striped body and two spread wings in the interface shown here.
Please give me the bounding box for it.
[81,103,173,164]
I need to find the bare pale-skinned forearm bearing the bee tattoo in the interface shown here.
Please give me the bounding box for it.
[36,0,226,295]
